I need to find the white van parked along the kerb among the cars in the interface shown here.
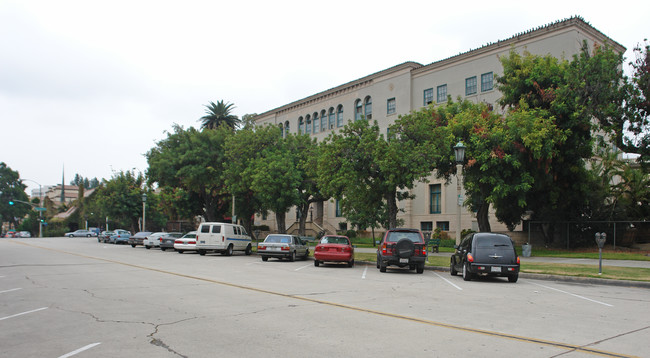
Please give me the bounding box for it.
[196,223,252,256]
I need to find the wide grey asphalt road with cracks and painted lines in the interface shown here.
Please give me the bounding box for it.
[0,238,650,358]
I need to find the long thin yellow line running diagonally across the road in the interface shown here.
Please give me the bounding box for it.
[11,240,636,358]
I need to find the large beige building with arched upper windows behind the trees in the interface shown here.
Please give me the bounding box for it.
[255,17,625,237]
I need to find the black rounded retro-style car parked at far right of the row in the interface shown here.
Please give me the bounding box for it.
[449,232,520,282]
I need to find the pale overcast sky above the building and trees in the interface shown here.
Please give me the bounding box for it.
[0,0,650,194]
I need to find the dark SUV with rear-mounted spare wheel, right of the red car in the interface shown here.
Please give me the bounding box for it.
[377,229,427,273]
